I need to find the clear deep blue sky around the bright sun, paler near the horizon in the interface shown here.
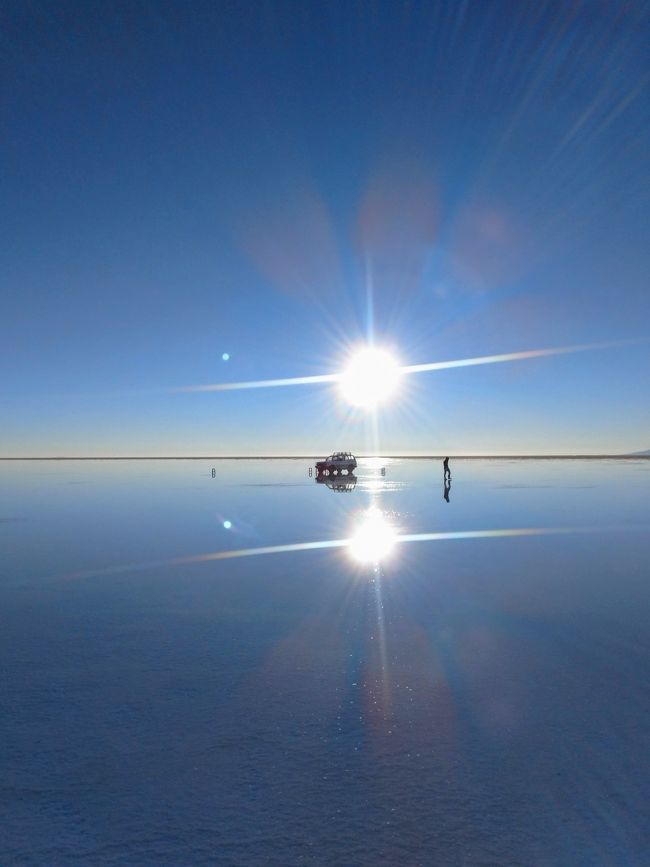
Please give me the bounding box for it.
[0,0,650,456]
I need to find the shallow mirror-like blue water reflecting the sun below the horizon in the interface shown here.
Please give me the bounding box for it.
[0,460,650,867]
